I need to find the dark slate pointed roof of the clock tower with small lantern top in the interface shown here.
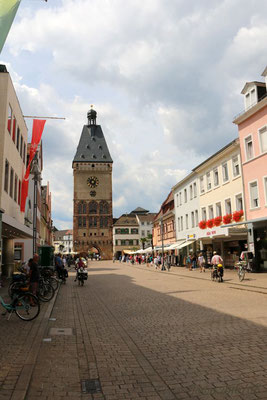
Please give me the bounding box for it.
[73,109,113,163]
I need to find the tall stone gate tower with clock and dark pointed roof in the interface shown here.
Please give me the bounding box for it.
[72,109,113,260]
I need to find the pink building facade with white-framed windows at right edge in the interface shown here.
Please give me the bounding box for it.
[233,68,267,270]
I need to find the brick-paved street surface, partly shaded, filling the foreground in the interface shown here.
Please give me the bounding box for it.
[0,261,267,400]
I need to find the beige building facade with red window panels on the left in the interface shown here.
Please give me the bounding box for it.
[0,65,32,275]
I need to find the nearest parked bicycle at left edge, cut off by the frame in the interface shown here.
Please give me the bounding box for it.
[0,292,40,321]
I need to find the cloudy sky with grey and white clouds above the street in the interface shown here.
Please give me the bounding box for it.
[0,0,267,229]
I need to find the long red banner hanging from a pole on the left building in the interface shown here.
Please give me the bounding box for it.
[20,119,46,212]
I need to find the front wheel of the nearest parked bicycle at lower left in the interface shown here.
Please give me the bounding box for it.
[14,292,40,321]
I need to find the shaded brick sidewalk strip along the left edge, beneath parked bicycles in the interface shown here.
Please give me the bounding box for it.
[0,281,57,400]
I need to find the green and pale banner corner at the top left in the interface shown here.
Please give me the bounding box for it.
[0,0,21,53]
